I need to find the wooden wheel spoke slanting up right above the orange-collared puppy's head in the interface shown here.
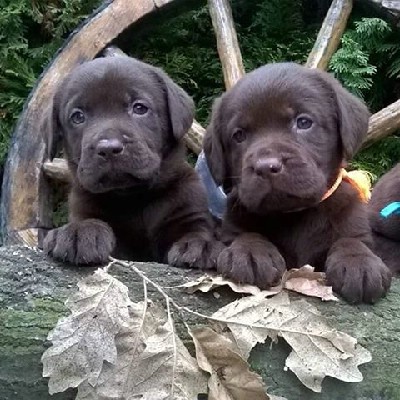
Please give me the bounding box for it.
[306,0,353,70]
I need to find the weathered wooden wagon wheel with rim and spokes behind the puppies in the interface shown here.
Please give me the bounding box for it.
[0,0,400,246]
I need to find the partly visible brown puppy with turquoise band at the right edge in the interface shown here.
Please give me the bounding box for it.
[368,164,400,274]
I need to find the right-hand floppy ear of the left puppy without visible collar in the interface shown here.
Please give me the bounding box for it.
[163,73,194,140]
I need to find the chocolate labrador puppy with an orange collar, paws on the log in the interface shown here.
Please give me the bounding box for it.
[204,63,391,302]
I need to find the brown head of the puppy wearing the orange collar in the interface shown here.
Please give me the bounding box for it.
[204,63,369,214]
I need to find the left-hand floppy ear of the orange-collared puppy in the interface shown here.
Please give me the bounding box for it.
[203,98,226,185]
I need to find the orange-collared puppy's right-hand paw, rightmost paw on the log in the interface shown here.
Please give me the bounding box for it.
[326,239,392,303]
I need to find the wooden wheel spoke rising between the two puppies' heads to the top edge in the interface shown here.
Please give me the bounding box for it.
[208,0,244,89]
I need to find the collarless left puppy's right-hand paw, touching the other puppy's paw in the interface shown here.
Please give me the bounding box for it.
[168,234,223,269]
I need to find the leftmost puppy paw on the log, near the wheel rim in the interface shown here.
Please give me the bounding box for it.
[43,219,115,265]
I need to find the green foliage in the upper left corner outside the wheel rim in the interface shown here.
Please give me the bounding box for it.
[0,0,101,163]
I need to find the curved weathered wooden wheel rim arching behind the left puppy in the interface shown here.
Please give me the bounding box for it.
[0,0,180,247]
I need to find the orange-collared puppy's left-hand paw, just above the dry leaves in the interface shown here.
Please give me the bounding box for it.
[217,234,286,289]
